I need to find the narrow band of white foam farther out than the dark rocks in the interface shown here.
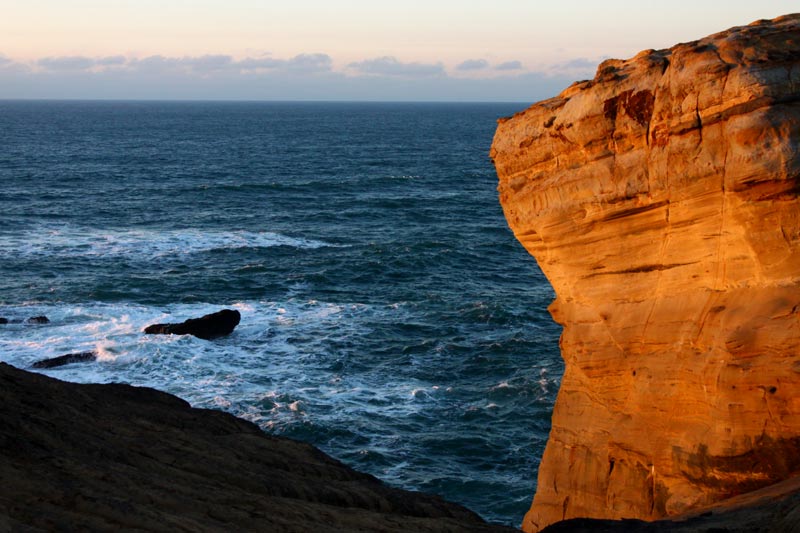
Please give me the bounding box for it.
[0,226,333,258]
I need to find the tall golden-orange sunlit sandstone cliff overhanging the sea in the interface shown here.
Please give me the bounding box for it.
[491,15,800,531]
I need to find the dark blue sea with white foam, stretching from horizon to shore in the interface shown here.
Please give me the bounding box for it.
[0,102,561,525]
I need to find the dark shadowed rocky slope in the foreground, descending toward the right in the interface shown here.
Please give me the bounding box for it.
[0,363,513,532]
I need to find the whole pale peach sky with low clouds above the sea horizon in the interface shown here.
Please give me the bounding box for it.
[0,0,800,102]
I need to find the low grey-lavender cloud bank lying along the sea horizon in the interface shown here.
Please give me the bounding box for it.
[0,53,599,101]
